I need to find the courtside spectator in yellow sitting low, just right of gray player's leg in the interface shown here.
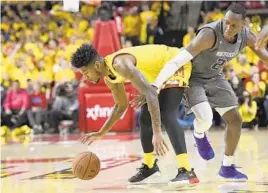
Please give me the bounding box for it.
[239,91,257,129]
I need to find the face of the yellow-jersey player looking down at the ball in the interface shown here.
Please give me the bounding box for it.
[80,61,101,84]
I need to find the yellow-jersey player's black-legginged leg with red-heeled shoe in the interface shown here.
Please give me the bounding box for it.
[159,87,199,185]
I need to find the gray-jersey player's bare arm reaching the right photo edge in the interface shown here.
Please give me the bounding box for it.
[247,30,268,65]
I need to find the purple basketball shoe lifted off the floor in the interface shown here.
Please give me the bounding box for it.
[194,133,215,160]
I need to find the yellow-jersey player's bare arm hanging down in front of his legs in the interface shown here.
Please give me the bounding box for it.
[114,56,168,155]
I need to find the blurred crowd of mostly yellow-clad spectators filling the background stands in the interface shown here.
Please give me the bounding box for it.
[0,1,268,142]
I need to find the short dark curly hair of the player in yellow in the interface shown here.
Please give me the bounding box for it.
[71,44,99,68]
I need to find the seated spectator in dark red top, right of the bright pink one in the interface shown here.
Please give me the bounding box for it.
[27,82,47,134]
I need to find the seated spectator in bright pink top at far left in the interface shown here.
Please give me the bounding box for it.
[3,80,29,129]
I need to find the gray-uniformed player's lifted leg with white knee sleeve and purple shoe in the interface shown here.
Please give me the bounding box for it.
[186,86,215,160]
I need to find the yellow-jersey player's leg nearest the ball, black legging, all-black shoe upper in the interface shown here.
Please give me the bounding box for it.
[128,104,160,183]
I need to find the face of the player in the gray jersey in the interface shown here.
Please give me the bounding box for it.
[223,11,244,40]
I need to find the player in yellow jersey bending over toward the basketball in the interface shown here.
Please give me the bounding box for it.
[71,44,199,186]
